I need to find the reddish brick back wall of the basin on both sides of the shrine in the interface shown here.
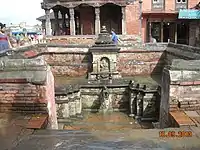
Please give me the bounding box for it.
[41,48,164,77]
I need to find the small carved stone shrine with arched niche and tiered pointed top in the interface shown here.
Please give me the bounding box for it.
[89,26,121,79]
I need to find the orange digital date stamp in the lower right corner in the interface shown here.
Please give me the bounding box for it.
[159,131,192,138]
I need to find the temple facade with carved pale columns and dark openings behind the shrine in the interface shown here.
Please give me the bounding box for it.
[41,0,140,35]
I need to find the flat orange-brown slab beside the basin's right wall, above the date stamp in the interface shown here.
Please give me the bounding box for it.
[170,111,196,127]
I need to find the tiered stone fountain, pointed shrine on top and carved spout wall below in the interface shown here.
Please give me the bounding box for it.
[56,27,160,123]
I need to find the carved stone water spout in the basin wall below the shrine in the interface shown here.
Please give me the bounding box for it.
[100,86,111,112]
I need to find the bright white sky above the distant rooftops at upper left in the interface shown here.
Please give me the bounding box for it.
[0,0,45,25]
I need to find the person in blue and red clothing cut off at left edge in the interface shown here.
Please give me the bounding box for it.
[0,23,12,52]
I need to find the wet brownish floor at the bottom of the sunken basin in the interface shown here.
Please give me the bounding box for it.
[60,112,152,132]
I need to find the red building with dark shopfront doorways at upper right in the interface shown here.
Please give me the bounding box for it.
[142,0,199,45]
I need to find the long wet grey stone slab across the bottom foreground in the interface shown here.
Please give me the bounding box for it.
[12,129,200,150]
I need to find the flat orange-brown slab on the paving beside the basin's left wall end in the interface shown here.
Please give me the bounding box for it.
[26,115,48,129]
